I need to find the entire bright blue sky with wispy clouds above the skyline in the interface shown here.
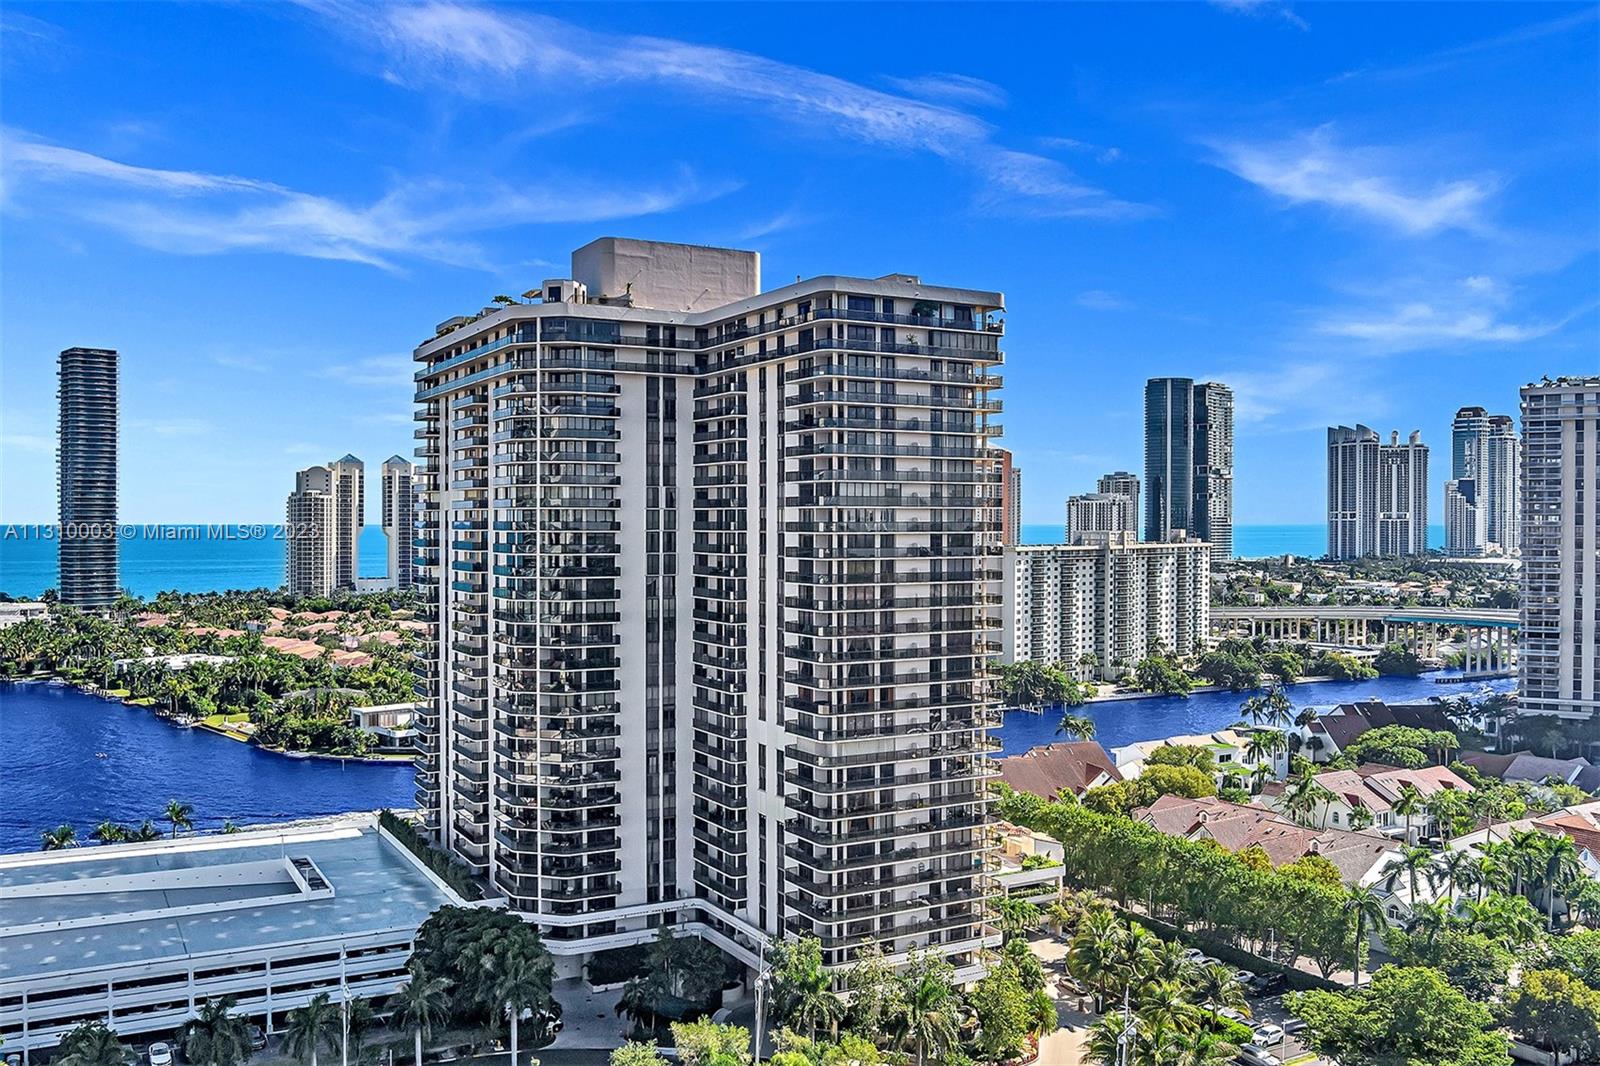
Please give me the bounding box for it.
[0,0,1600,523]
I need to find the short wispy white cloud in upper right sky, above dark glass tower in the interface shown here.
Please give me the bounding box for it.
[1213,126,1499,235]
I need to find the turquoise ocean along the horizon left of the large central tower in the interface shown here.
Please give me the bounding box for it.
[0,525,389,599]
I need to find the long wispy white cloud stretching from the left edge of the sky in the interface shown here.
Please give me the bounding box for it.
[0,130,731,271]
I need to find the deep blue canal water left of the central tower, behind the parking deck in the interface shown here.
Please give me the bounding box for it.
[0,682,414,852]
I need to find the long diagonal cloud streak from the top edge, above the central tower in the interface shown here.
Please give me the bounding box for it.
[302,0,1149,218]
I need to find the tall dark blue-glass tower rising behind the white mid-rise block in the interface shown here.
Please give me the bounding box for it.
[1144,378,1234,562]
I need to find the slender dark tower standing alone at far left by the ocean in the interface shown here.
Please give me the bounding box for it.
[56,347,118,607]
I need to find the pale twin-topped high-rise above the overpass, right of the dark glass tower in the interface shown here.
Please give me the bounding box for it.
[1328,424,1427,559]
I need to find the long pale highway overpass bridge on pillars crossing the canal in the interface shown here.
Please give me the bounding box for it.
[1211,605,1520,674]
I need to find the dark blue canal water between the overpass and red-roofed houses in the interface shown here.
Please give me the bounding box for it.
[995,674,1517,755]
